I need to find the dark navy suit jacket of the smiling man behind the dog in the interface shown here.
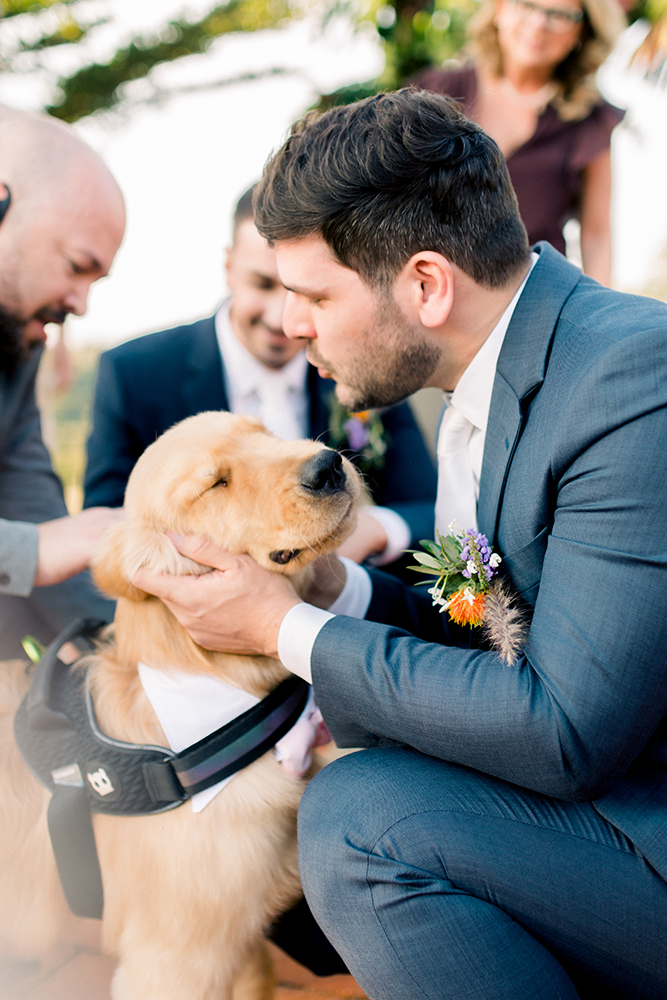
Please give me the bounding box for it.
[84,317,436,556]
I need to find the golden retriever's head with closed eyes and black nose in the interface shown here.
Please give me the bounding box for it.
[94,412,361,600]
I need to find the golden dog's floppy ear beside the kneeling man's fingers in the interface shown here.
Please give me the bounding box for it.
[91,521,210,601]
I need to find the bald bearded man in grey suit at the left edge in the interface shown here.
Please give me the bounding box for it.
[0,107,125,658]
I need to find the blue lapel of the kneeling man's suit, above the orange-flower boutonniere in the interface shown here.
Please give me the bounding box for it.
[477,243,581,543]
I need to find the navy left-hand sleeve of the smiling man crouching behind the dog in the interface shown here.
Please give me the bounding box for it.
[83,352,143,507]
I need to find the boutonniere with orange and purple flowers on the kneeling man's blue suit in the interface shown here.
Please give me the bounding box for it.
[409,521,527,666]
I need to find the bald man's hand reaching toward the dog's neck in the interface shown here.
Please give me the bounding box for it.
[34,507,125,587]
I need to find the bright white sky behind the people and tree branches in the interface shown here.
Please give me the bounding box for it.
[0,0,667,347]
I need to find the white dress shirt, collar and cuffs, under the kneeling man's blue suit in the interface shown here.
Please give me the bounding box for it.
[278,253,539,684]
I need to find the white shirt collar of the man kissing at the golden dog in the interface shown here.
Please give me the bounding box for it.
[445,253,540,432]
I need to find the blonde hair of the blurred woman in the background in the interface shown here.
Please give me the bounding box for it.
[468,0,626,121]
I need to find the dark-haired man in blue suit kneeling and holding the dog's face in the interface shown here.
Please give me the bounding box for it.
[133,91,667,1000]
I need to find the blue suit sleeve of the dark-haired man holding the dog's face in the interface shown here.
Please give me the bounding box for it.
[312,334,667,800]
